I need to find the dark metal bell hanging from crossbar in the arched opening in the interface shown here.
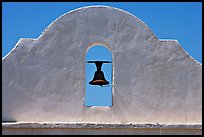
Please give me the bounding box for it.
[89,61,109,86]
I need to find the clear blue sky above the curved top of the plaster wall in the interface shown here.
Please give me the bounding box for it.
[2,2,202,106]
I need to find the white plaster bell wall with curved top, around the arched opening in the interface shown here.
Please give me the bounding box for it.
[2,6,202,124]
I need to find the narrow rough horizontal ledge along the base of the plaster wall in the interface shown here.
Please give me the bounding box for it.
[2,122,202,130]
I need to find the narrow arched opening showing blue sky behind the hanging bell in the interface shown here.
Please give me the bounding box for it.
[85,45,112,107]
